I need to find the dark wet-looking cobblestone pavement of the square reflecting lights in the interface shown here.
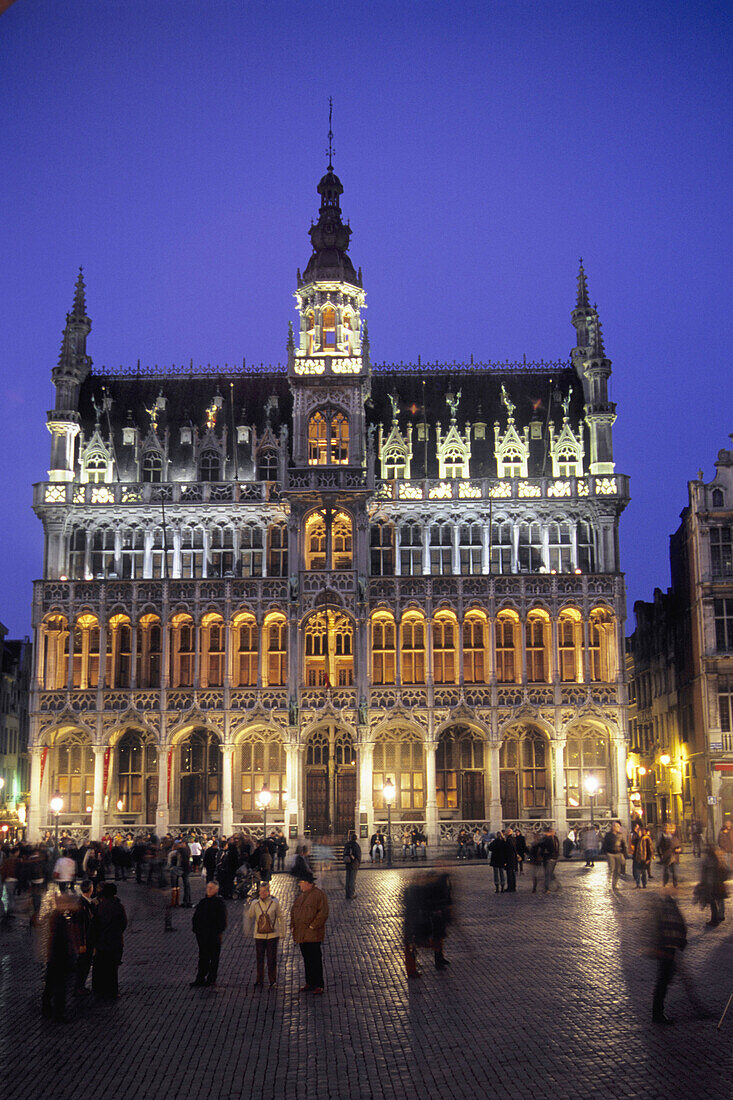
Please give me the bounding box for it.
[0,860,733,1100]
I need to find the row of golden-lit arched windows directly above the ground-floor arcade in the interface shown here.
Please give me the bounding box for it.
[39,608,619,690]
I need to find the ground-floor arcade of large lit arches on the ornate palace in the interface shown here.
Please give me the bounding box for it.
[32,721,626,842]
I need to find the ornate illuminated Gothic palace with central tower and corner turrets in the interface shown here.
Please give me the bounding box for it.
[24,157,628,843]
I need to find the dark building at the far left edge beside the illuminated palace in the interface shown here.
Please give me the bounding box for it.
[0,624,32,824]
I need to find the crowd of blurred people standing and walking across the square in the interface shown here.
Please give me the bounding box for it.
[0,818,733,1023]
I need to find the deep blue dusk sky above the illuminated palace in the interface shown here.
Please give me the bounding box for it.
[0,0,733,636]
